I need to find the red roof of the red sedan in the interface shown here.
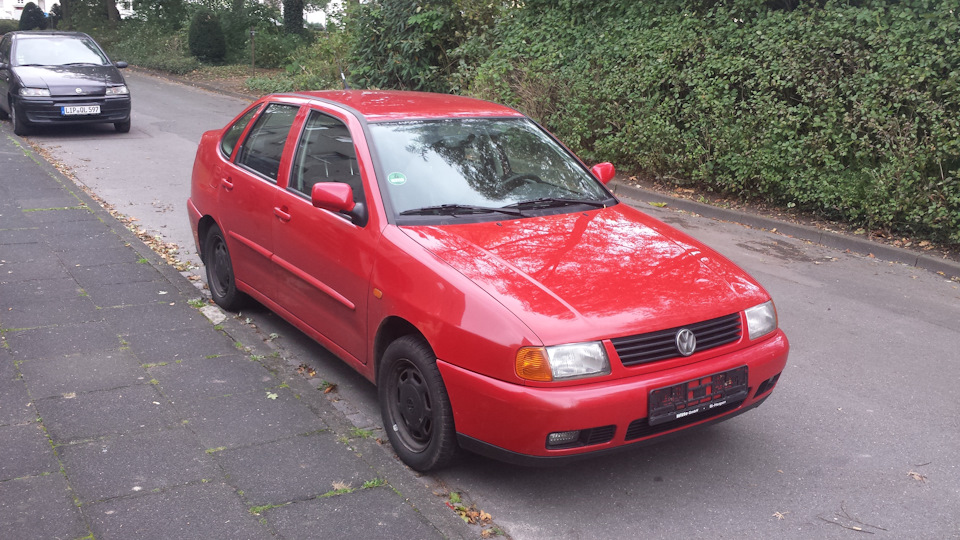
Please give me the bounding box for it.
[294,90,523,122]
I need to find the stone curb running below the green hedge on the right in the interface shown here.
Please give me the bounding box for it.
[608,179,960,280]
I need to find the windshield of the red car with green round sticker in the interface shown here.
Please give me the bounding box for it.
[370,118,610,219]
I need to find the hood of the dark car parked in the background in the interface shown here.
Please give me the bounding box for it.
[13,65,124,96]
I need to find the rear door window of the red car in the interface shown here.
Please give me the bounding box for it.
[237,103,299,182]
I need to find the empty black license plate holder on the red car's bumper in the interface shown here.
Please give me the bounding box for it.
[647,366,748,426]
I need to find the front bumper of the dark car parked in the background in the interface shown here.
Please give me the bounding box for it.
[17,95,130,126]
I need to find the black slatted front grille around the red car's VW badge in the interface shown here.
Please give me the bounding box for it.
[610,313,742,366]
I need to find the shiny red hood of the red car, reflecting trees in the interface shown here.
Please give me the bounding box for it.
[403,204,769,344]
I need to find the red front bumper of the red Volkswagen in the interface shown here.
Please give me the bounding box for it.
[438,330,789,464]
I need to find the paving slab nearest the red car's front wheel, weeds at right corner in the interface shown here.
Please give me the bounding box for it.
[215,431,368,506]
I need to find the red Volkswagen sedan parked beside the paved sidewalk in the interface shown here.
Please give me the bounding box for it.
[188,91,789,471]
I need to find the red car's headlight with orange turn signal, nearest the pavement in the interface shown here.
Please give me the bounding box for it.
[516,341,610,382]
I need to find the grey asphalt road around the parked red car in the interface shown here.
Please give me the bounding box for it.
[24,73,960,539]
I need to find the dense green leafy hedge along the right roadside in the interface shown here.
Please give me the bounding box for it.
[472,0,960,243]
